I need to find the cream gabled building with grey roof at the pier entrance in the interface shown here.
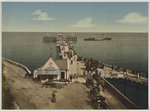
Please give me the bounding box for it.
[33,57,69,80]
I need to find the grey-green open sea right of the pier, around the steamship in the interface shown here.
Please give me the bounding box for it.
[75,33,148,73]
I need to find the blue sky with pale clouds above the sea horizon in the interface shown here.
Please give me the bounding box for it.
[2,2,148,32]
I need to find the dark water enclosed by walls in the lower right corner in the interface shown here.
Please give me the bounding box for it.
[107,79,148,109]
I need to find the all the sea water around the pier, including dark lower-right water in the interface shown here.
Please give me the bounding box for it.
[2,32,148,109]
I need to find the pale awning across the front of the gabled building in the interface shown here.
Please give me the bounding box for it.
[37,70,61,75]
